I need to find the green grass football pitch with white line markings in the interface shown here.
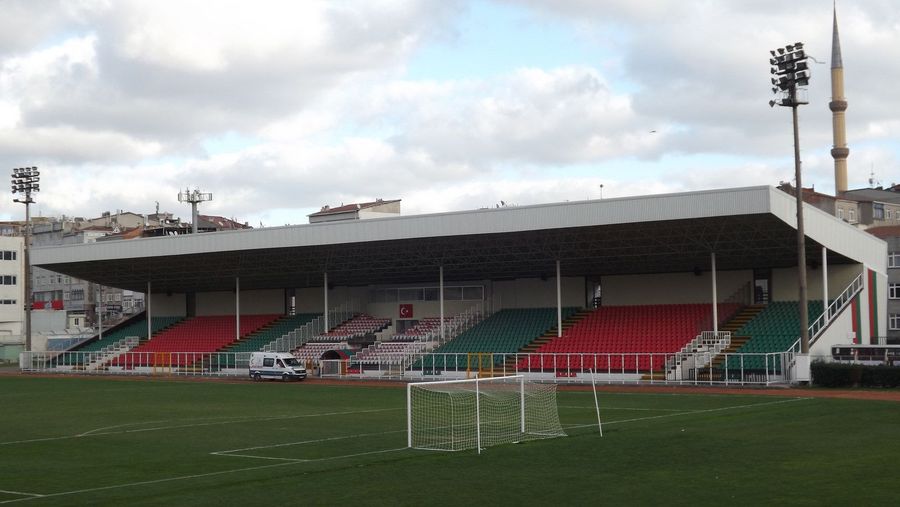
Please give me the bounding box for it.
[0,377,900,506]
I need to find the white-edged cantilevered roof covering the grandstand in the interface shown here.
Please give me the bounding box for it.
[31,186,887,292]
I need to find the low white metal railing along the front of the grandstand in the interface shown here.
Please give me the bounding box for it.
[19,351,795,385]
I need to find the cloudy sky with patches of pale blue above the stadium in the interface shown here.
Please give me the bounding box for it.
[0,0,900,227]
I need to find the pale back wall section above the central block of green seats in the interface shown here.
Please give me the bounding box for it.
[491,277,585,310]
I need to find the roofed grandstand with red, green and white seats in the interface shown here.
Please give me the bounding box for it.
[24,187,887,382]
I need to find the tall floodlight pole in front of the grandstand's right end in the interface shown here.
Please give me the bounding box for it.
[769,42,809,354]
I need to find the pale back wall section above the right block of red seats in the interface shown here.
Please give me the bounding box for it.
[601,270,753,306]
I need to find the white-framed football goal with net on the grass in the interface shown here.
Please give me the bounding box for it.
[406,375,566,452]
